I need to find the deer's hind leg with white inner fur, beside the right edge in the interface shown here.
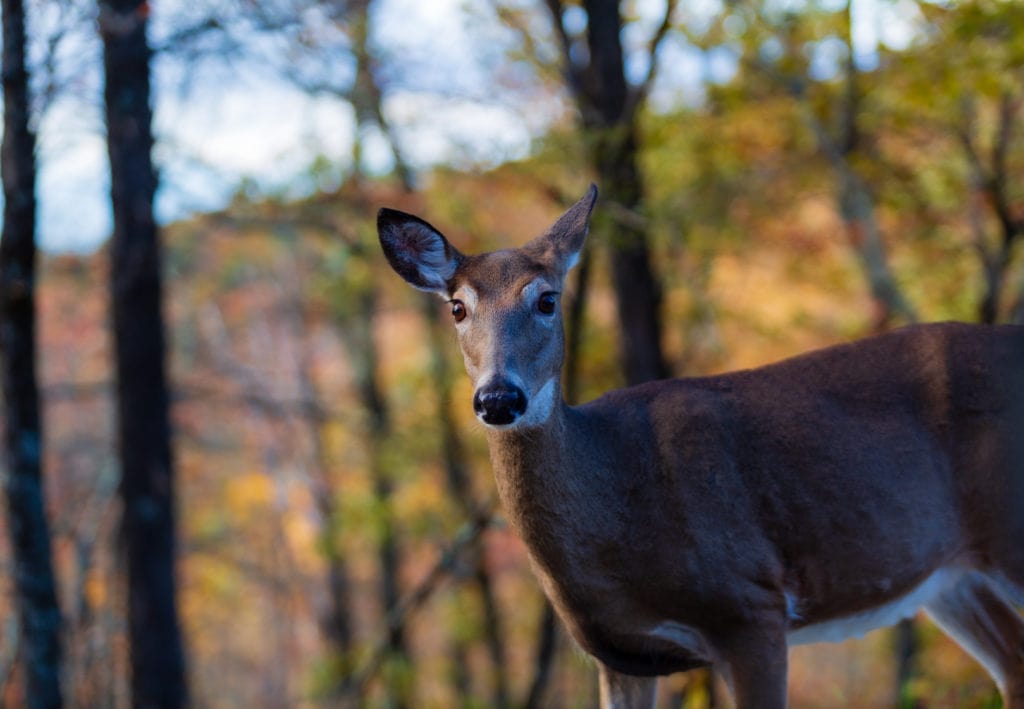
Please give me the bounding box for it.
[925,573,1024,709]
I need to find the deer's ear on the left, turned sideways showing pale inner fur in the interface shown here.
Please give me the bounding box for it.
[377,209,463,295]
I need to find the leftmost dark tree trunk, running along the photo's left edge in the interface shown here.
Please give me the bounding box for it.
[0,0,61,707]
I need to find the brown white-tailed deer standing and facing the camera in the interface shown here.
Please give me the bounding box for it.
[377,184,1024,709]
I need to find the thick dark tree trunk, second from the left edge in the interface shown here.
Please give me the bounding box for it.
[99,0,187,707]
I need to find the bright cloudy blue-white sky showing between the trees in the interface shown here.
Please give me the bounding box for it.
[12,0,921,251]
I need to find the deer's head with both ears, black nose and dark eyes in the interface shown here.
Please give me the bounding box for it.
[377,185,597,429]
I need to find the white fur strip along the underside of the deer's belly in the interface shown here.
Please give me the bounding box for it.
[785,568,965,645]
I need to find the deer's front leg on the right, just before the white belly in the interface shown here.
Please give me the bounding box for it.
[722,627,788,709]
